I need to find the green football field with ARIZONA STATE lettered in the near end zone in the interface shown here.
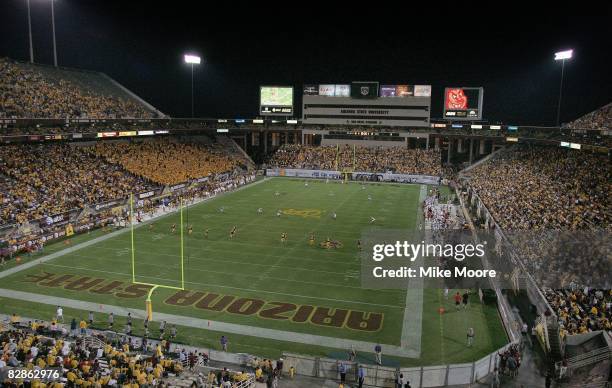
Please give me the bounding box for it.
[0,178,507,366]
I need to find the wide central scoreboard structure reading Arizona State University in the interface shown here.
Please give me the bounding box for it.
[302,81,431,127]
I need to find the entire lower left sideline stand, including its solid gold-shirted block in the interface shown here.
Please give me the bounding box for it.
[0,139,249,224]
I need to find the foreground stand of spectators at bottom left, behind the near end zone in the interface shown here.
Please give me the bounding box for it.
[0,314,260,388]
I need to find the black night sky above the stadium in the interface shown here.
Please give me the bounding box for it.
[0,0,612,125]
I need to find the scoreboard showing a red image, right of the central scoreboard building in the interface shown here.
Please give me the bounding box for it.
[443,87,483,120]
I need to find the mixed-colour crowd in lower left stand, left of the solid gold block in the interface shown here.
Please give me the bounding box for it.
[0,144,149,224]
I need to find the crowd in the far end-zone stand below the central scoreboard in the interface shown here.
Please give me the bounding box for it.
[268,144,442,176]
